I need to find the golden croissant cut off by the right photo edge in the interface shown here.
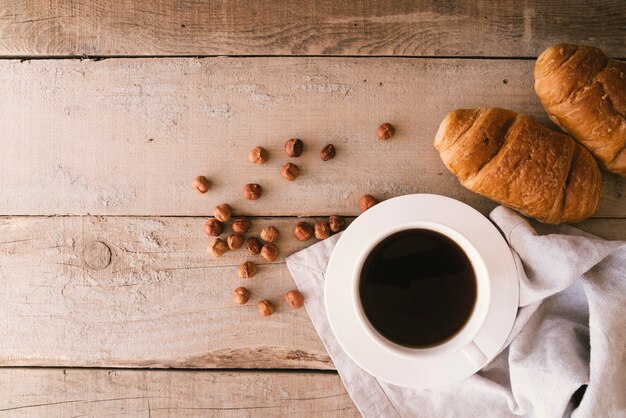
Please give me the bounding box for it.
[535,44,626,177]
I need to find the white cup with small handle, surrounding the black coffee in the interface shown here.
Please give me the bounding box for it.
[351,221,491,367]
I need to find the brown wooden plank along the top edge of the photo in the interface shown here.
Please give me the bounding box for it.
[0,0,626,57]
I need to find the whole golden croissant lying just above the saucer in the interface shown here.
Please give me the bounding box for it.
[434,108,602,224]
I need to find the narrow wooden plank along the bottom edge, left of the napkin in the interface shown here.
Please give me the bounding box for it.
[0,368,360,418]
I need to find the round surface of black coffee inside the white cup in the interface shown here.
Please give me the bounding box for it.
[359,229,476,348]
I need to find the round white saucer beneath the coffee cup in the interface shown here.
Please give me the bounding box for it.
[324,194,519,388]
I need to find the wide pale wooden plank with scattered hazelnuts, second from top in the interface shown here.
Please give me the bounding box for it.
[0,58,626,217]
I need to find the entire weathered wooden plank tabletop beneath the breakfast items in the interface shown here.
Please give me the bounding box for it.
[0,0,626,417]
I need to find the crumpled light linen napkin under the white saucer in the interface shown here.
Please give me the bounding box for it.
[287,206,626,418]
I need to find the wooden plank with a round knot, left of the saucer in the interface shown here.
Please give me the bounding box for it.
[0,217,626,370]
